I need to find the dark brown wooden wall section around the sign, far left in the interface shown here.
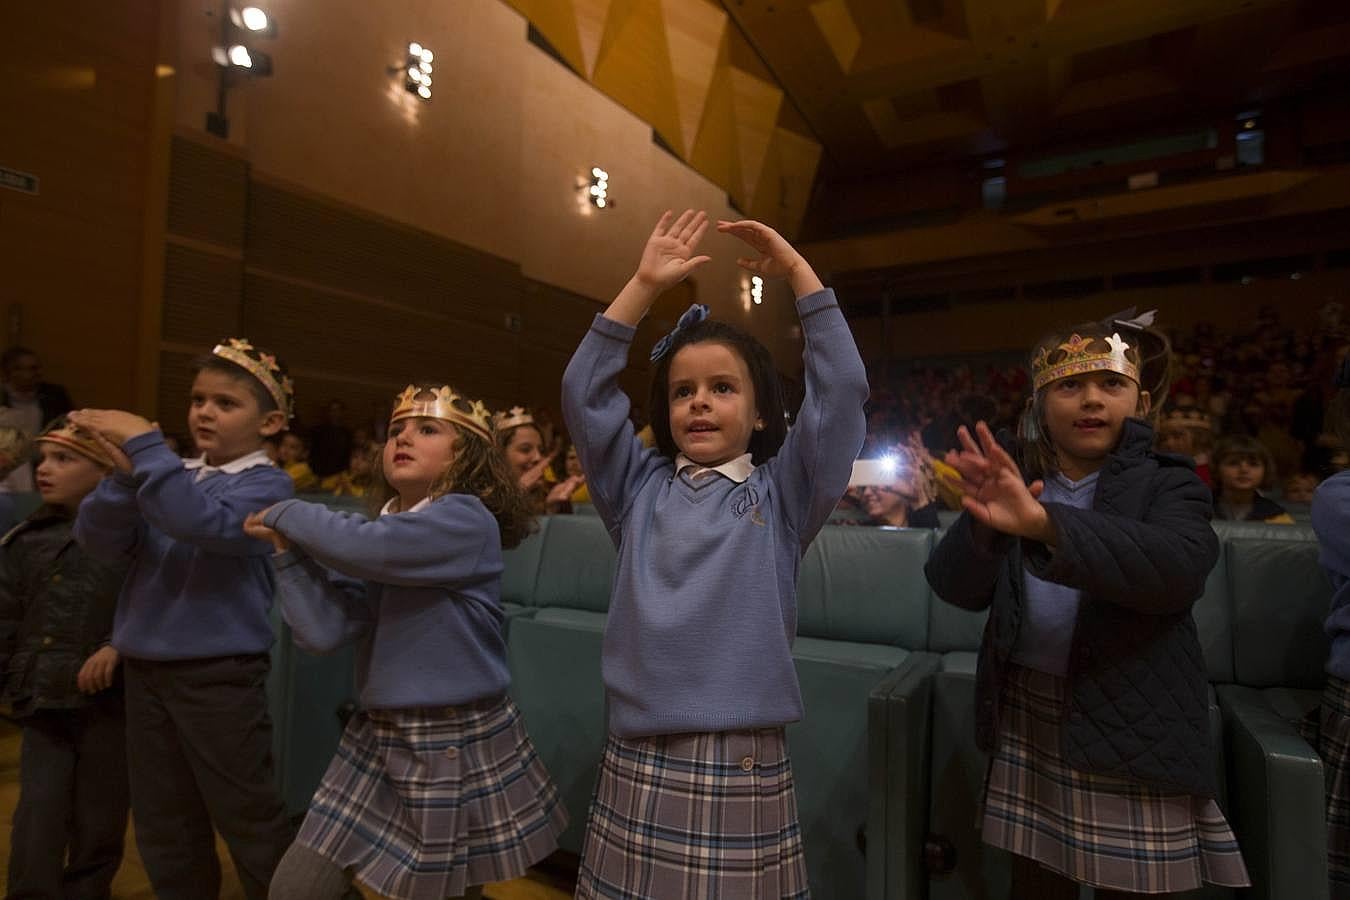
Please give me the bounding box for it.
[0,0,162,406]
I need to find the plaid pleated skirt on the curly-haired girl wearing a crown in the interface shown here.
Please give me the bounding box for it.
[296,698,567,900]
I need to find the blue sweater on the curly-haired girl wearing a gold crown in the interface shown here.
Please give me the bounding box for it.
[265,494,510,708]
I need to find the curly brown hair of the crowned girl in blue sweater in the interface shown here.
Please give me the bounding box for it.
[370,389,537,549]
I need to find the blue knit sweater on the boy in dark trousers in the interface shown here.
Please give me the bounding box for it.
[76,432,294,660]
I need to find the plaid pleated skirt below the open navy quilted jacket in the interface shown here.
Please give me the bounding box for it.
[981,665,1250,893]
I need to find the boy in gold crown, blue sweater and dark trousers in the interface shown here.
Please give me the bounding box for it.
[70,339,293,900]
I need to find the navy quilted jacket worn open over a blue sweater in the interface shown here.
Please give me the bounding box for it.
[925,420,1219,796]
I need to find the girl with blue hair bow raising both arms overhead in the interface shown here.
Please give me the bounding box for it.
[563,210,867,900]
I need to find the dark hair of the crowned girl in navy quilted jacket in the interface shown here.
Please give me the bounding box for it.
[1018,317,1172,478]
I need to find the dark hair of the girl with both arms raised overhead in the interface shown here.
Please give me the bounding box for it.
[648,318,787,466]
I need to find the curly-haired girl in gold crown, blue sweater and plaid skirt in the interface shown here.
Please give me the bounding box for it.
[244,385,567,900]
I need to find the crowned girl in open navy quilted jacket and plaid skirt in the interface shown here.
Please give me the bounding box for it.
[926,314,1247,900]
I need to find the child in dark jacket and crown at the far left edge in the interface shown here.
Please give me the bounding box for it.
[0,418,130,897]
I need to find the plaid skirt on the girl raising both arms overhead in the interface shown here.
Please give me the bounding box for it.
[576,729,810,900]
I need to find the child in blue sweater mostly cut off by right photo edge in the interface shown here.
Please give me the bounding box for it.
[1312,355,1350,900]
